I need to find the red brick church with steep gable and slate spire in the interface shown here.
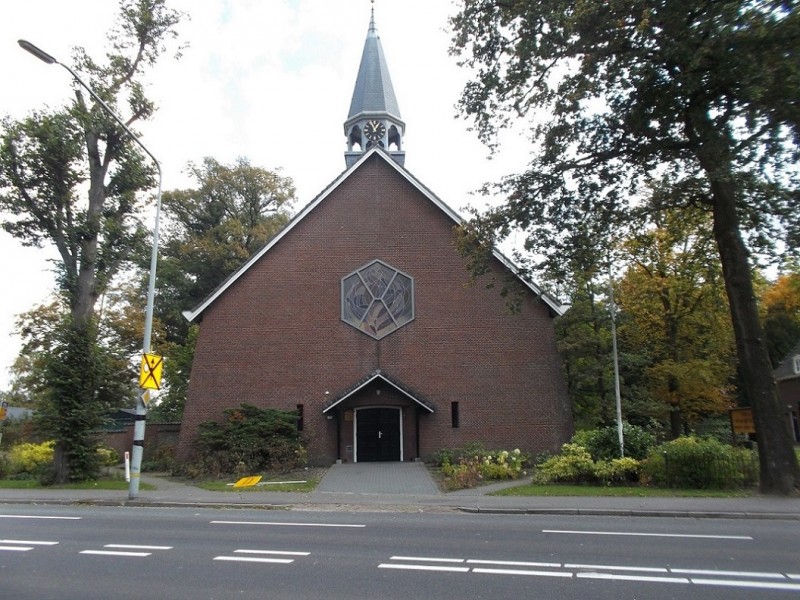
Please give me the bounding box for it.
[178,12,572,465]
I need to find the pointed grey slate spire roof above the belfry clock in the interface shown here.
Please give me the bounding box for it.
[347,4,401,121]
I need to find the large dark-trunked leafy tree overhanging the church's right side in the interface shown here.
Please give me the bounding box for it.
[451,0,800,494]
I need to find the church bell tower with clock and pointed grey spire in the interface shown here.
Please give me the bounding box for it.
[344,0,406,168]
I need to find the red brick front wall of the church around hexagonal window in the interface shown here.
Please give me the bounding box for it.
[180,156,571,463]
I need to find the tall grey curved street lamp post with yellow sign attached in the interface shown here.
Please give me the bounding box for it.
[18,40,162,500]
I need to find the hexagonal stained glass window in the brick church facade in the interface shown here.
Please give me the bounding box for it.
[342,260,414,340]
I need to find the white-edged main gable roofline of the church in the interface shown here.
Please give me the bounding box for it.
[183,146,564,322]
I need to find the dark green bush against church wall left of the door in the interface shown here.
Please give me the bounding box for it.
[190,404,306,475]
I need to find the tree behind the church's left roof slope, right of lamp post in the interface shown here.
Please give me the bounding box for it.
[148,158,295,420]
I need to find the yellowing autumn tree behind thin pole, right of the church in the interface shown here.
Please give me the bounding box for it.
[618,204,735,437]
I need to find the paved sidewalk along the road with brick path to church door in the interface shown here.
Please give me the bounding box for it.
[0,463,800,521]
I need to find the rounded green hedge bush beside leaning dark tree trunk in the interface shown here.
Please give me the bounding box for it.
[642,436,758,489]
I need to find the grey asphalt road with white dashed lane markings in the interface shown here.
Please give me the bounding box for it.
[0,505,800,600]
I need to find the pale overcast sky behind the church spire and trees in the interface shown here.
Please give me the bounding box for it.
[0,0,527,389]
